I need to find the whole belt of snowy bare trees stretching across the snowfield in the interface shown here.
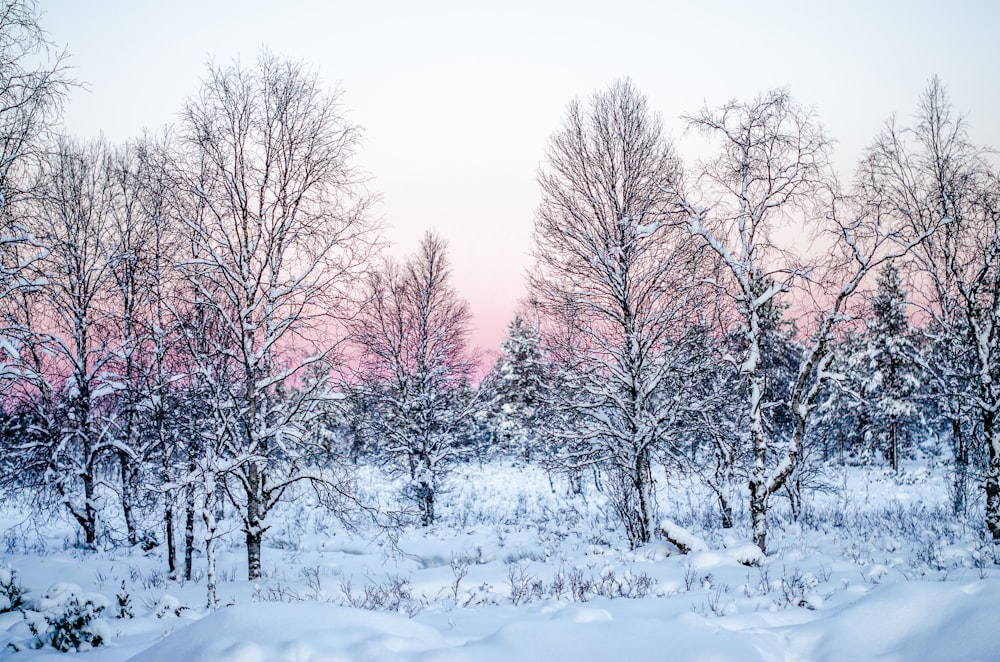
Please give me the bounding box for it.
[0,0,1000,659]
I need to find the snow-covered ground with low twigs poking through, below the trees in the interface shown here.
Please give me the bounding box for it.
[0,462,1000,662]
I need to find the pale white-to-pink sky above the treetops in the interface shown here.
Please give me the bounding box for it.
[40,0,1000,352]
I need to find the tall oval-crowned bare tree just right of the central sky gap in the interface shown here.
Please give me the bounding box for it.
[530,80,695,546]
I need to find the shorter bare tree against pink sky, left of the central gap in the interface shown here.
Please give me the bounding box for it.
[353,233,476,526]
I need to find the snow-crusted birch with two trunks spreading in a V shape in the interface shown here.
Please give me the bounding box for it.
[681,90,933,550]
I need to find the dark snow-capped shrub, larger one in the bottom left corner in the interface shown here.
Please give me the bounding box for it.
[24,583,111,653]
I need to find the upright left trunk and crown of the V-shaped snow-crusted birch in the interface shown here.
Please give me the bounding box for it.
[686,90,830,550]
